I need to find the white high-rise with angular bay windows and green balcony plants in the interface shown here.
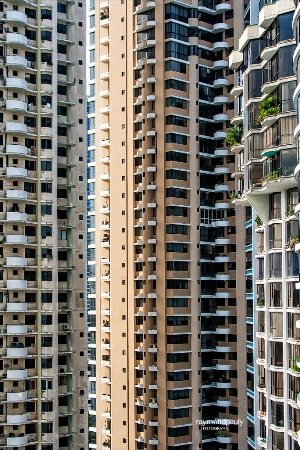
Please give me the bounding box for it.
[230,0,300,450]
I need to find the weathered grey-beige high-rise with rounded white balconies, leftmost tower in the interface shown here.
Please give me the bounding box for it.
[0,0,88,450]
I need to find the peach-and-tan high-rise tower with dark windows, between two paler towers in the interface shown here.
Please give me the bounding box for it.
[88,0,248,450]
